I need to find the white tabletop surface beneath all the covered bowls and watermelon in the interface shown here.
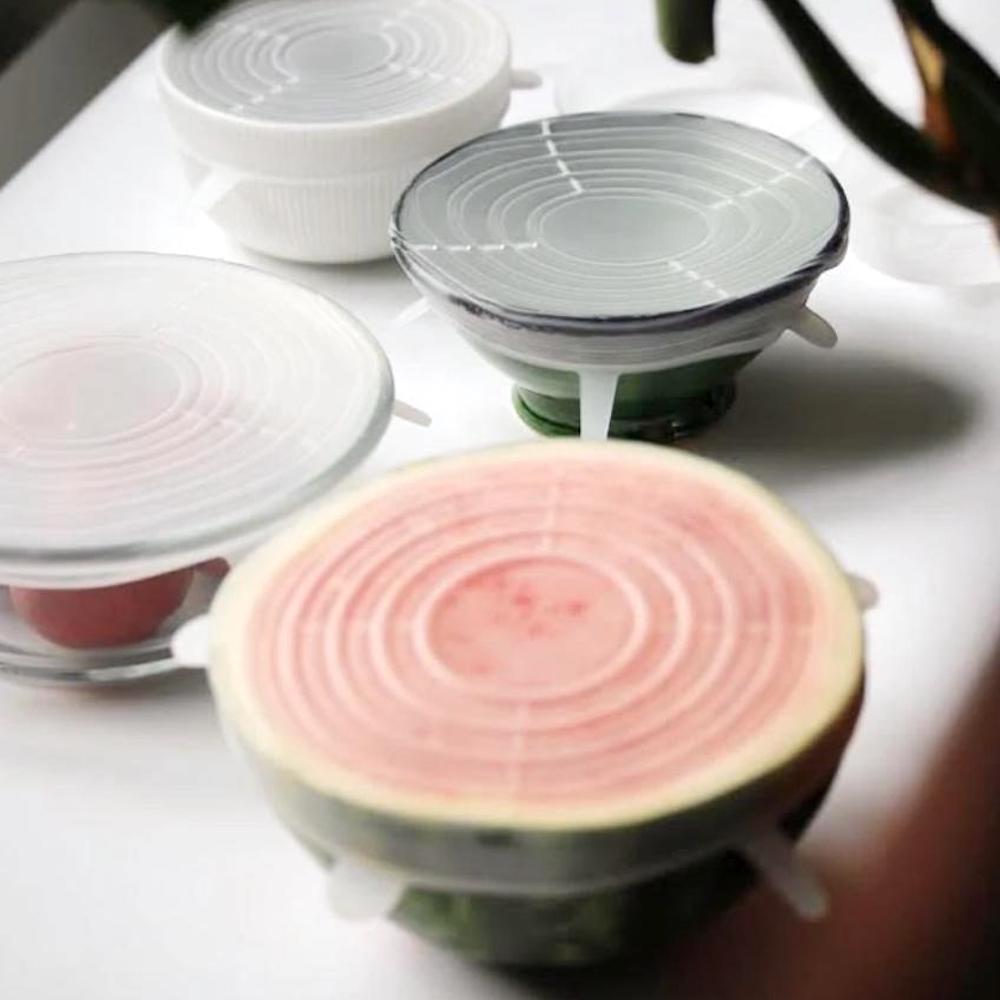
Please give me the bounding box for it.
[0,0,1000,1000]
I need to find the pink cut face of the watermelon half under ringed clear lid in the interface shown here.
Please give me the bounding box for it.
[221,442,860,822]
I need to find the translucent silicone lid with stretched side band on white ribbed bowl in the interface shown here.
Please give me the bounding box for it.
[160,0,510,177]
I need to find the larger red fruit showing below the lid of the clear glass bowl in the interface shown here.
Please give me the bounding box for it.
[10,569,194,649]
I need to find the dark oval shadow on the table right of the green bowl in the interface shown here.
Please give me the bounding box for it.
[693,351,977,482]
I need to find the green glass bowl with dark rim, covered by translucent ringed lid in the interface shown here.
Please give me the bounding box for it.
[390,111,850,442]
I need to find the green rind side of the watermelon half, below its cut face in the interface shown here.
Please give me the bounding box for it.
[229,692,862,966]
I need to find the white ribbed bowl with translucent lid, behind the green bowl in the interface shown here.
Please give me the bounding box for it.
[158,0,511,262]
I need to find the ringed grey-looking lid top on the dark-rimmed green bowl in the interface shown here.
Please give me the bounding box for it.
[393,112,847,320]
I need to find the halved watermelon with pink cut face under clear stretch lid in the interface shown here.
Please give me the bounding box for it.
[208,441,863,964]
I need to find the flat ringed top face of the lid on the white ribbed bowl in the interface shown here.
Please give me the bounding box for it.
[166,0,507,124]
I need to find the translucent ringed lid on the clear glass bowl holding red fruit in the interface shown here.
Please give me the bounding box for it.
[0,254,392,586]
